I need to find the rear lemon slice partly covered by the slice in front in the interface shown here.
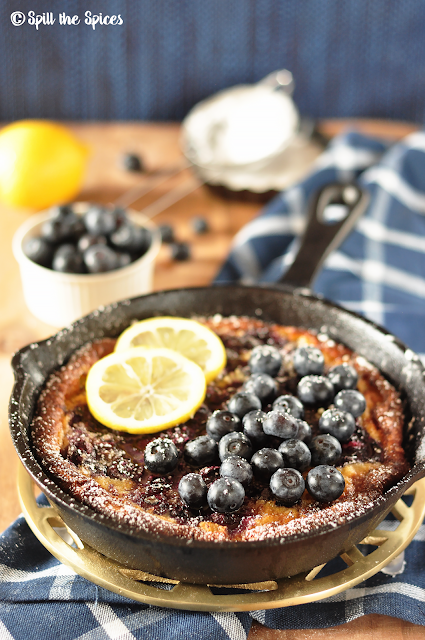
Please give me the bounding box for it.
[115,317,226,383]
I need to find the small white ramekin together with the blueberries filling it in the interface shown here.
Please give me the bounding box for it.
[13,202,161,327]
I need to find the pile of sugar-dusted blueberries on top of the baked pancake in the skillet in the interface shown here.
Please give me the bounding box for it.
[145,345,366,513]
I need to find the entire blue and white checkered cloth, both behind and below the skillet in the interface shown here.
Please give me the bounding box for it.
[0,133,425,640]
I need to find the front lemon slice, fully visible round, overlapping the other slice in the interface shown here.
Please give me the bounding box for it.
[86,347,206,433]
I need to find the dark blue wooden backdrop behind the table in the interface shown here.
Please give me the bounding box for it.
[0,0,425,122]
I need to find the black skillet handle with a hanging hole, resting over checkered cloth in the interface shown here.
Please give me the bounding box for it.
[278,183,369,289]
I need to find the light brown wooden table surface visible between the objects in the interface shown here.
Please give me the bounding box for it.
[0,121,425,640]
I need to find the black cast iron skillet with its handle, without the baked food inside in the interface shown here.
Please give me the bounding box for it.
[10,185,425,584]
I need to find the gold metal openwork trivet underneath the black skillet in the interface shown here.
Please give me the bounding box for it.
[18,466,425,611]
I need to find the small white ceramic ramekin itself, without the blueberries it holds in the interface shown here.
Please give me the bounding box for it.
[13,203,161,327]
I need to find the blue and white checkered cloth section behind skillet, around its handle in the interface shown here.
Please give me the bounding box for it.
[216,132,425,355]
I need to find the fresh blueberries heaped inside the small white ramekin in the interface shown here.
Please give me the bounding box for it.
[23,205,152,273]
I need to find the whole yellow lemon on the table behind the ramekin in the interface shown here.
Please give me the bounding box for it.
[0,120,88,209]
